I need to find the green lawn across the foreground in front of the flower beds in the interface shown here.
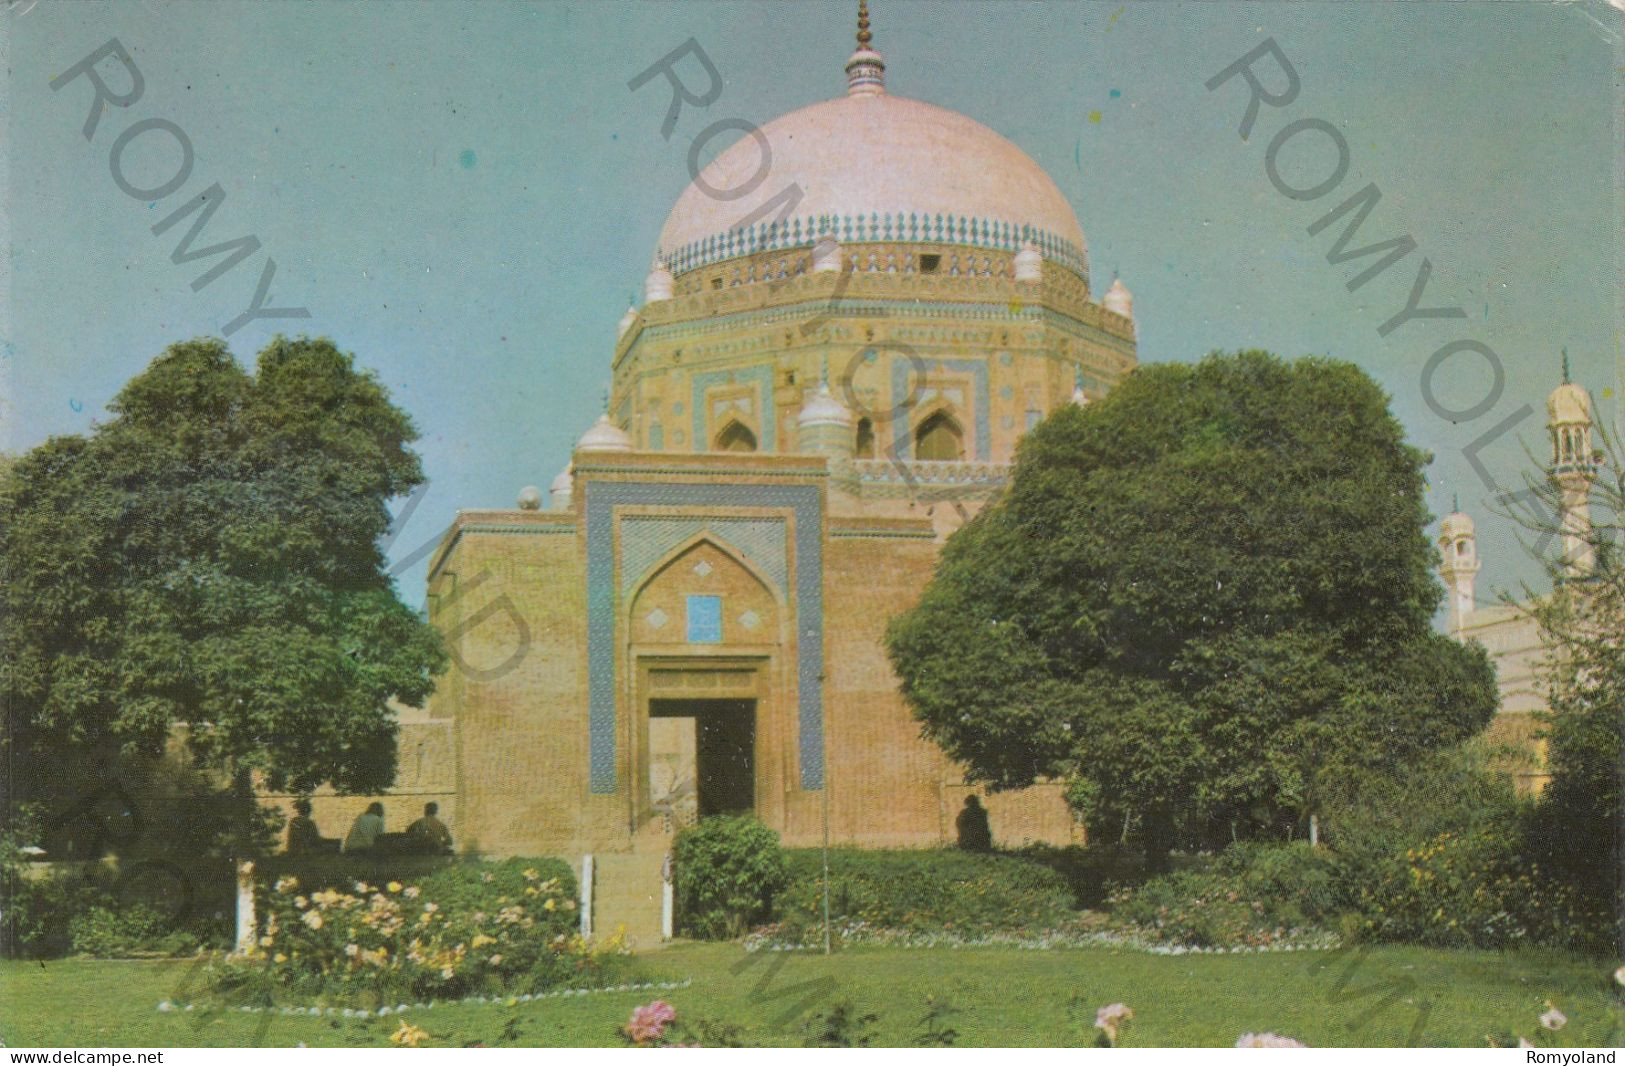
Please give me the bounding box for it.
[0,944,1625,1048]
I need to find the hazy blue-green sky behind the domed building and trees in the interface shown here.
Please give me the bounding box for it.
[0,0,1625,603]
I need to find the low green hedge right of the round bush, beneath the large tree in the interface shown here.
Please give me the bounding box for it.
[777,848,1074,941]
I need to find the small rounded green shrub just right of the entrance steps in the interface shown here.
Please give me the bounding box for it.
[671,814,787,939]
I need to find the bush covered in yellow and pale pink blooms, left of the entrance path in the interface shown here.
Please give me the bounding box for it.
[216,860,620,1003]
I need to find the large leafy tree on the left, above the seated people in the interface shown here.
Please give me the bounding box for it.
[0,338,445,825]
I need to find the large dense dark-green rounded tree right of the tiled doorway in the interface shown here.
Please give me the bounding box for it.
[887,351,1497,861]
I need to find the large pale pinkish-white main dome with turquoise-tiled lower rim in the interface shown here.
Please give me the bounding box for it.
[660,91,1087,275]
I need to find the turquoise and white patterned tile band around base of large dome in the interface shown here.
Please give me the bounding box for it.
[663,211,1089,281]
